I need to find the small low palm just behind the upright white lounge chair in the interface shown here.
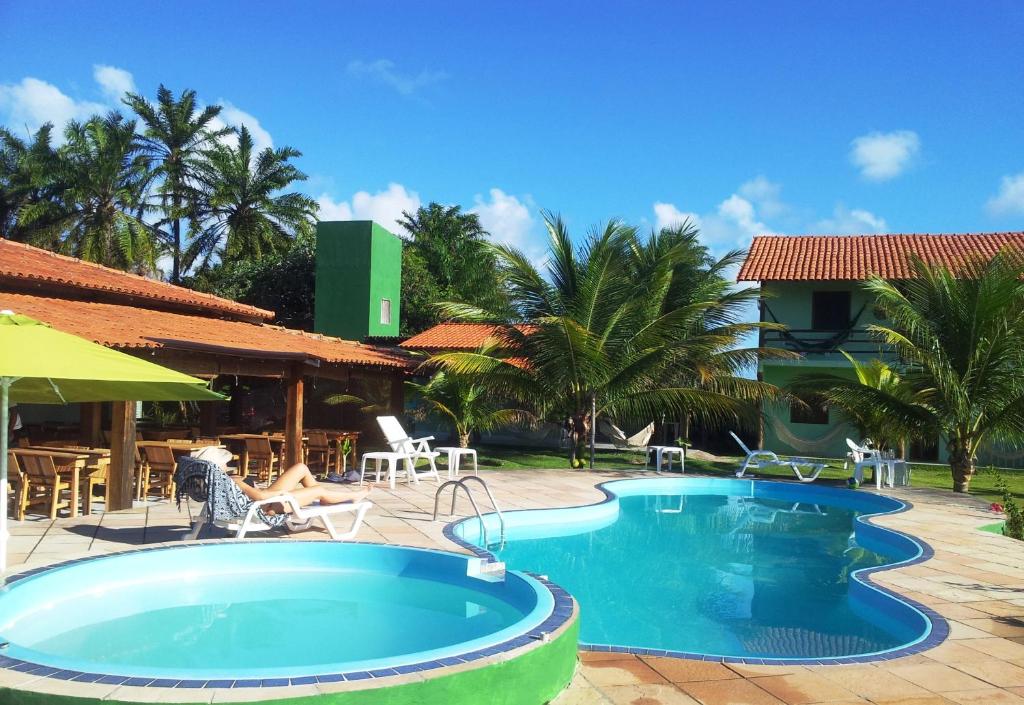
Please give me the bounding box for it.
[406,372,534,448]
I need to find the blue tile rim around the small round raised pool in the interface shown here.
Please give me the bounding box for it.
[0,541,575,689]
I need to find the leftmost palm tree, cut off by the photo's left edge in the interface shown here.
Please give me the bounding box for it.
[0,123,60,246]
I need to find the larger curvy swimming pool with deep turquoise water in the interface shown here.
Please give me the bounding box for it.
[450,479,945,662]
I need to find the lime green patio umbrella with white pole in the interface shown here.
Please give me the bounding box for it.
[0,310,224,571]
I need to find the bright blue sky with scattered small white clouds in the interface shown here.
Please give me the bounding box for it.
[0,0,1024,258]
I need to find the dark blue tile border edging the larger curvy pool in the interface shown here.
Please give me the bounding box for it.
[443,474,949,666]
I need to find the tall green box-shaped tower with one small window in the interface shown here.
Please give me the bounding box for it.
[313,220,401,340]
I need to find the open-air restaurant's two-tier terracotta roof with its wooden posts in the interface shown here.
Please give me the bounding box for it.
[0,241,416,510]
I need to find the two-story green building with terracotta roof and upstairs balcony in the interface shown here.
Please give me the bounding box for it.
[736,233,1024,466]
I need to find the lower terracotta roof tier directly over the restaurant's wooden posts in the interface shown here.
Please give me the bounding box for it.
[0,292,416,369]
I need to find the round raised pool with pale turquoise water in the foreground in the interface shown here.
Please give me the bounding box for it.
[0,541,553,678]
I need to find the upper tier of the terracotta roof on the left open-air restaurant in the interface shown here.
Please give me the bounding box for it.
[0,239,273,321]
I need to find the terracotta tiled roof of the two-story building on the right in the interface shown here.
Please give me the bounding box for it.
[736,233,1024,282]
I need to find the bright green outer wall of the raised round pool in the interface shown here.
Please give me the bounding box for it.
[0,617,580,705]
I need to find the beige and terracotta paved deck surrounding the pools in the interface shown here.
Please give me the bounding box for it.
[2,470,1024,705]
